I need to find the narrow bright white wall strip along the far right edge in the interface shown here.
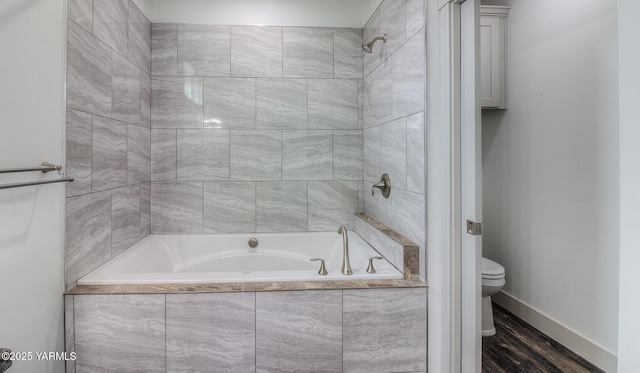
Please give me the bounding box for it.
[618,0,640,373]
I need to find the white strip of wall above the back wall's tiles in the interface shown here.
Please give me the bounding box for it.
[135,0,381,28]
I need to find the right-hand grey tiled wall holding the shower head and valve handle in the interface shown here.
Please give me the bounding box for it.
[363,0,426,279]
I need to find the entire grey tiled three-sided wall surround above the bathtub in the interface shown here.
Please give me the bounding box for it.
[67,0,425,284]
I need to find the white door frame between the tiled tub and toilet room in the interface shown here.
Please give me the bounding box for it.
[426,0,482,373]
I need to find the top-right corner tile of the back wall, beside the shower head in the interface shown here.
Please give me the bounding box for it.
[333,28,363,78]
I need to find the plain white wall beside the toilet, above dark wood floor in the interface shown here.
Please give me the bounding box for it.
[483,0,620,371]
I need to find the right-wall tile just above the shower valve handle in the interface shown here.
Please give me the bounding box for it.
[380,118,407,190]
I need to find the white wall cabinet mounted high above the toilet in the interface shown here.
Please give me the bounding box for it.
[480,5,509,109]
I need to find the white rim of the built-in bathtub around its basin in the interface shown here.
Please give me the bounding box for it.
[74,230,406,287]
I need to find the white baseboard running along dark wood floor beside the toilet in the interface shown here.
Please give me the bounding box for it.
[491,291,618,373]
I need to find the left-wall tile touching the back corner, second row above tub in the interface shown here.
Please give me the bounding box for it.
[127,124,151,184]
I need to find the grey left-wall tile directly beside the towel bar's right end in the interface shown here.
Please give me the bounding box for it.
[66,109,92,197]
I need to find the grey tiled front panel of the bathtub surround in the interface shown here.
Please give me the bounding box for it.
[65,287,427,373]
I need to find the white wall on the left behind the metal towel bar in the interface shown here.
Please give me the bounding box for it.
[0,0,65,372]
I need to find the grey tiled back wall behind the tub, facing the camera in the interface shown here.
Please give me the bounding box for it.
[151,24,363,233]
